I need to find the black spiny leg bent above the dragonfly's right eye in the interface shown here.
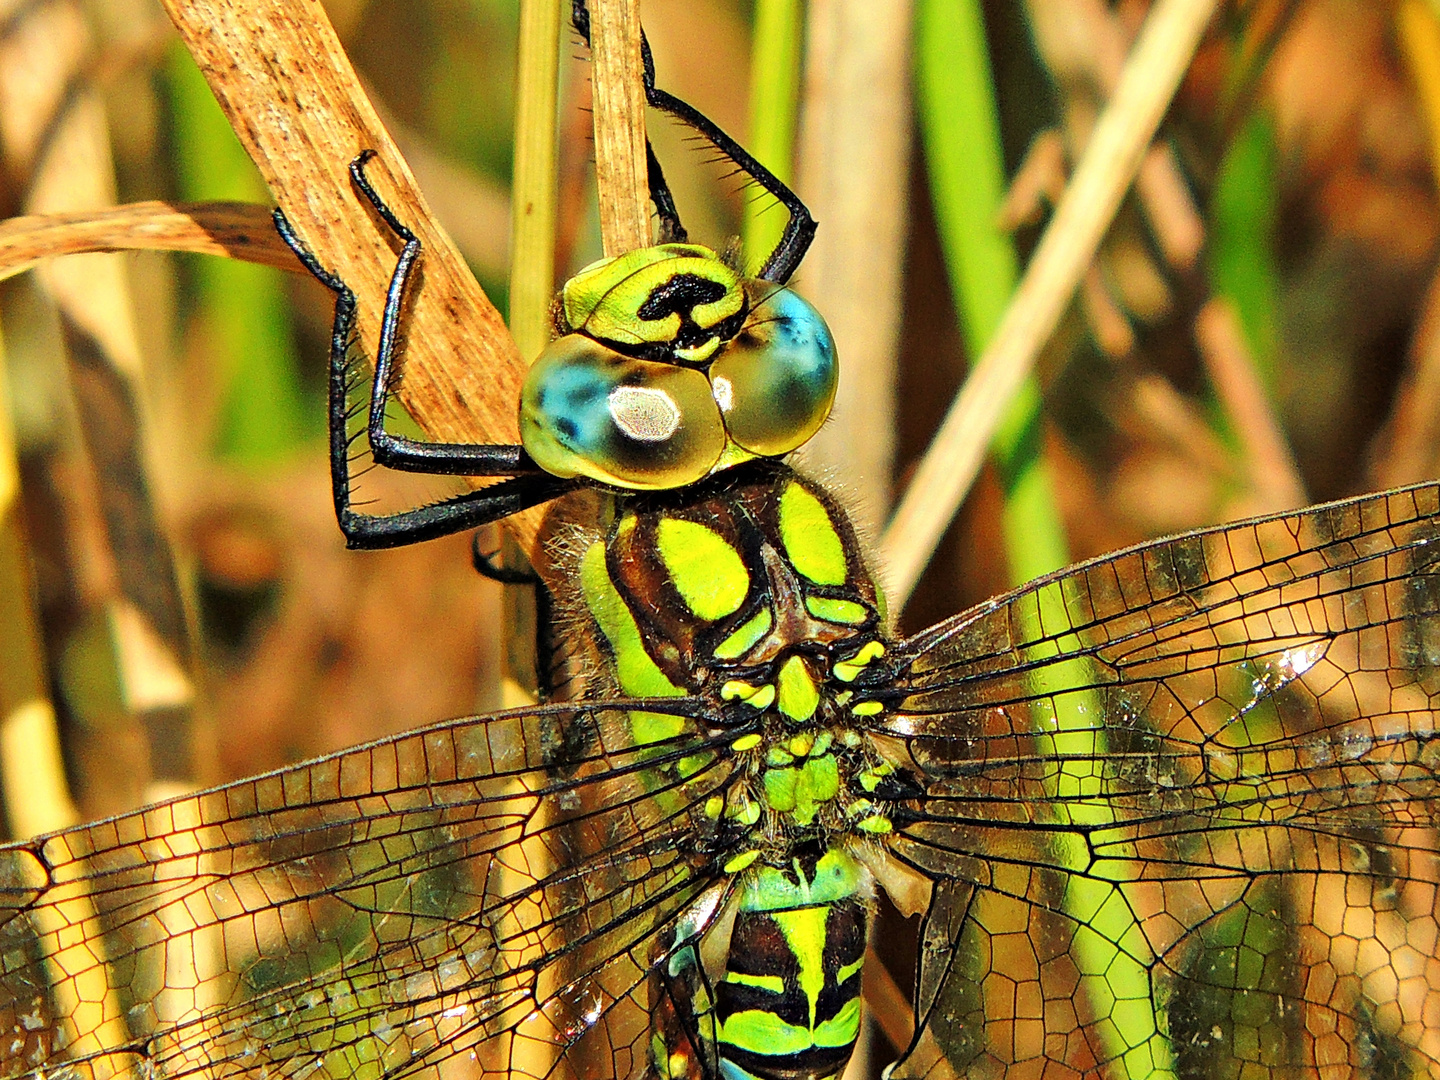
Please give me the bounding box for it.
[570,0,815,285]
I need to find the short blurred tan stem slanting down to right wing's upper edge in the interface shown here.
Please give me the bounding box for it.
[1195,298,1310,514]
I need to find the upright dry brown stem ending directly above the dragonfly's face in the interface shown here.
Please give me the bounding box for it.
[590,0,651,256]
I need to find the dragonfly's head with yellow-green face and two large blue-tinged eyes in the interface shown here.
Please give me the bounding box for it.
[520,243,838,491]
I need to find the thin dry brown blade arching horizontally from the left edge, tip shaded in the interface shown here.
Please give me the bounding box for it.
[0,202,305,279]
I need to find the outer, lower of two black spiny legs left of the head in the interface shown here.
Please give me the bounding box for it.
[275,210,575,549]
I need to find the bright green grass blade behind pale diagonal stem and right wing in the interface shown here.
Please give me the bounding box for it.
[916,0,1174,1080]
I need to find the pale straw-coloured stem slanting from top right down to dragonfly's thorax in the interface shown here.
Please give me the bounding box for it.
[881,0,1217,609]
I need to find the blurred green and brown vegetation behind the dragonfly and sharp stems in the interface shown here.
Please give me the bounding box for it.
[0,0,1440,852]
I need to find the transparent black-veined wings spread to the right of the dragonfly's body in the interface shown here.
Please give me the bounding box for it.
[873,485,1440,1079]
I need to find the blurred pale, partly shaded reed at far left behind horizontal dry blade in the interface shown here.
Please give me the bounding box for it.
[0,0,197,809]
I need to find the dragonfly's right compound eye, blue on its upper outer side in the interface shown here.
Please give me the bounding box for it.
[710,282,840,456]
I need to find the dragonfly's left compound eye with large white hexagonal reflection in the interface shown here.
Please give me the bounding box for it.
[520,334,726,490]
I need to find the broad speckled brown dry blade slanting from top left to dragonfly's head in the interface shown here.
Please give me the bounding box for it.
[154,0,536,547]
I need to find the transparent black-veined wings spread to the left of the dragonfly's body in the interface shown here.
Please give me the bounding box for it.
[0,701,729,1080]
